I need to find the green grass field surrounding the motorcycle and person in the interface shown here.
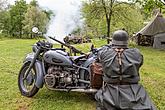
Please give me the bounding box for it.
[0,39,165,110]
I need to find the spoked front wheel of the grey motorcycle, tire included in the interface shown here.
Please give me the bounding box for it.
[18,62,39,97]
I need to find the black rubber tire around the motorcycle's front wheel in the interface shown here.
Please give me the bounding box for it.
[18,62,39,97]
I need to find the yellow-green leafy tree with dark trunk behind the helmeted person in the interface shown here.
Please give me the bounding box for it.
[82,0,143,37]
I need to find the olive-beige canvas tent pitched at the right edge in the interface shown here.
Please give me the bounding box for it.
[137,14,165,49]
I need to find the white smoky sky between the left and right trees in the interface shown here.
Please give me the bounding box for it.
[8,0,82,40]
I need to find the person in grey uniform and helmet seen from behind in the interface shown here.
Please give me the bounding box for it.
[95,30,156,110]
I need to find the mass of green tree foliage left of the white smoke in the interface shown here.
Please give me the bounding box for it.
[0,0,52,38]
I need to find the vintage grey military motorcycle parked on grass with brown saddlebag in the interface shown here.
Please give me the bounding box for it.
[18,27,102,97]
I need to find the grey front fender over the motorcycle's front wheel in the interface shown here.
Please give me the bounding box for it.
[23,53,44,88]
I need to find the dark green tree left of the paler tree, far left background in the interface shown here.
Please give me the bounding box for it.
[9,0,27,38]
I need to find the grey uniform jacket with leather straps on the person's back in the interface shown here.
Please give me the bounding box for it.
[98,47,143,83]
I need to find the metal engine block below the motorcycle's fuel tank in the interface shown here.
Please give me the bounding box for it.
[44,66,73,88]
